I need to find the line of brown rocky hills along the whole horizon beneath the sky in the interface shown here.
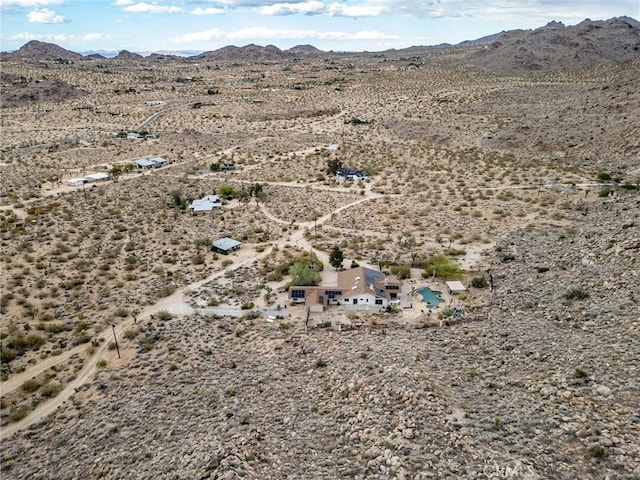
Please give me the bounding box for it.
[2,17,640,71]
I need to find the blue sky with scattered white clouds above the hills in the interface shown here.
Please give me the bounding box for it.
[0,0,640,52]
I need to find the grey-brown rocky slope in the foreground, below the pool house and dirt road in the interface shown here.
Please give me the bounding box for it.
[2,192,640,480]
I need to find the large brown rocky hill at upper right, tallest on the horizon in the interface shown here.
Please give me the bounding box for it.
[467,17,640,72]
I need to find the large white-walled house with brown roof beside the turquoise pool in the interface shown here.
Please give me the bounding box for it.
[289,267,401,312]
